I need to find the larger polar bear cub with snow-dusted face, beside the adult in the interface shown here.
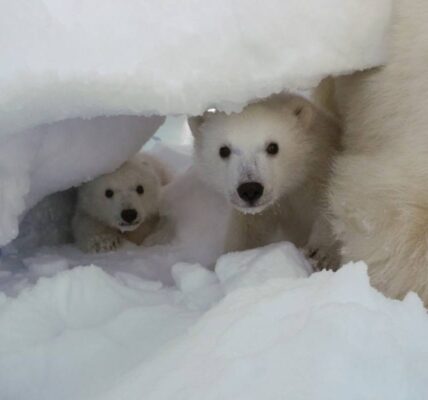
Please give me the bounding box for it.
[189,94,341,268]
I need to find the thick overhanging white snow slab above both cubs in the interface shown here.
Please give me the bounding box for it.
[0,0,390,135]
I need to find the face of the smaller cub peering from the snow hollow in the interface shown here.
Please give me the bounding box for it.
[79,163,160,232]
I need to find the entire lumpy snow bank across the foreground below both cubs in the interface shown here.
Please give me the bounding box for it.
[0,243,428,400]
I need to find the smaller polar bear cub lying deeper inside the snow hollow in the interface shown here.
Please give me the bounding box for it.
[72,153,169,252]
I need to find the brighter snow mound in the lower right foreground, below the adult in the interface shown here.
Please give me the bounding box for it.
[99,258,428,400]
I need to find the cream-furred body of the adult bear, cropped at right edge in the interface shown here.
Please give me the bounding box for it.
[330,0,428,305]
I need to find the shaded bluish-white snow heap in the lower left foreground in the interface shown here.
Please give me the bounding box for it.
[0,267,198,400]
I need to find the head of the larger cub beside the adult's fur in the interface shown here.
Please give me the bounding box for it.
[189,95,316,213]
